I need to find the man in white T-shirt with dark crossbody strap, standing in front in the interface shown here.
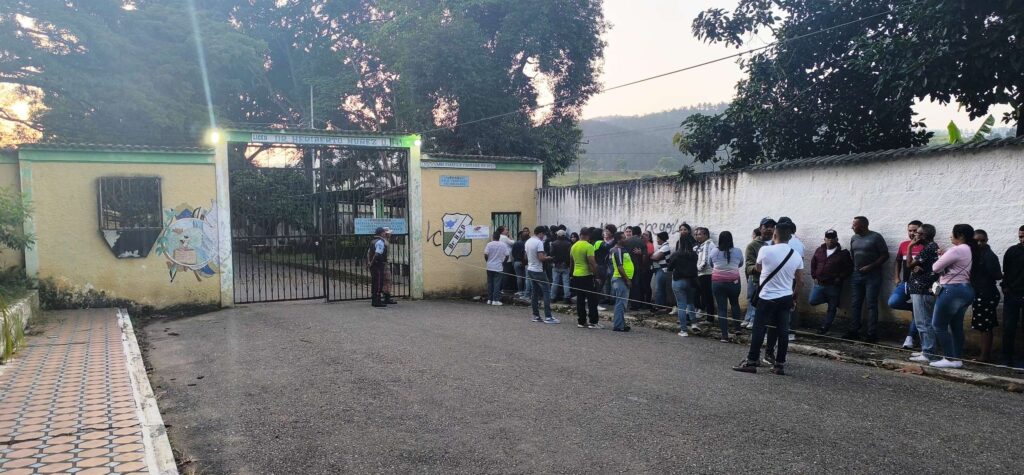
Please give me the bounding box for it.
[732,221,804,375]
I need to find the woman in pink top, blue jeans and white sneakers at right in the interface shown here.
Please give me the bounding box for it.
[930,224,981,368]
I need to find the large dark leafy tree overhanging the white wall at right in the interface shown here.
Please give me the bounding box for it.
[676,0,1024,167]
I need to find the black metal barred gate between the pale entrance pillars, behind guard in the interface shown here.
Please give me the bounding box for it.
[229,145,411,303]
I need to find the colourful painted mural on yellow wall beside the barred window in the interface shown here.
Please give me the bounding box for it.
[157,205,218,283]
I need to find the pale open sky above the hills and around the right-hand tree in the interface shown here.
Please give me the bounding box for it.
[584,0,1010,129]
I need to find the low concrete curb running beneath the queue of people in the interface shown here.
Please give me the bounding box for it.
[499,298,1024,393]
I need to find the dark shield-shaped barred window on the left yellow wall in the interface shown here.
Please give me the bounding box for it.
[97,176,163,258]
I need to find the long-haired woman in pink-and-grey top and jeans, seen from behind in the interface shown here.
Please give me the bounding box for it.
[708,231,743,343]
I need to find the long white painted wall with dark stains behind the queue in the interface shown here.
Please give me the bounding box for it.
[538,145,1024,335]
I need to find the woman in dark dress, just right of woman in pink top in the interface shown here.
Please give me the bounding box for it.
[971,229,1002,362]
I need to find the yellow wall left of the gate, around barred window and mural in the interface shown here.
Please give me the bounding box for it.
[23,159,220,307]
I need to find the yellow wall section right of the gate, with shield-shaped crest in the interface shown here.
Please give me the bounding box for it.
[422,168,538,298]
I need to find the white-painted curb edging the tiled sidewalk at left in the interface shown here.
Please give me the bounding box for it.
[118,308,178,475]
